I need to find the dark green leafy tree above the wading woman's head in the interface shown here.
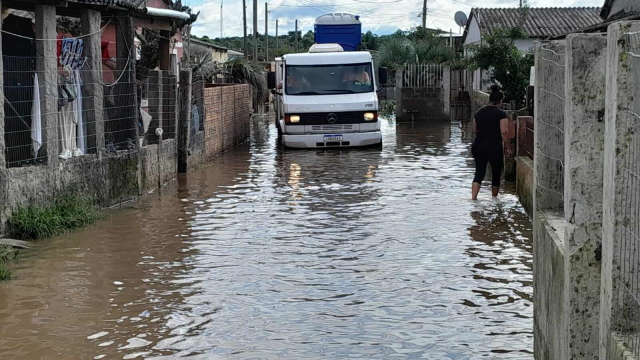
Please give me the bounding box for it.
[467,28,534,105]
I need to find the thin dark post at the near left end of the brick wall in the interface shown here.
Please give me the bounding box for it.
[178,70,192,173]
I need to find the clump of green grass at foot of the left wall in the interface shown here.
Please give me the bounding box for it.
[8,193,102,240]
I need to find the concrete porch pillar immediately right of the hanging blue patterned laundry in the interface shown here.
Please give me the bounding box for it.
[80,9,104,154]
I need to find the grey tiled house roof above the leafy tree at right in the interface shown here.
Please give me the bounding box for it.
[463,7,602,41]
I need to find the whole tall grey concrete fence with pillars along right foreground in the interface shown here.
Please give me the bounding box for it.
[536,22,640,360]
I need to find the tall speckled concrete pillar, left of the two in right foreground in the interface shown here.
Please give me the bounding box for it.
[564,34,607,359]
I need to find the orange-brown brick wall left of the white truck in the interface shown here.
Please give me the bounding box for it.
[204,85,251,159]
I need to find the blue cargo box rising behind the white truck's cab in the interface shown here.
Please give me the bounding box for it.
[314,13,362,51]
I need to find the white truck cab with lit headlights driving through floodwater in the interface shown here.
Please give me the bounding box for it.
[267,44,387,148]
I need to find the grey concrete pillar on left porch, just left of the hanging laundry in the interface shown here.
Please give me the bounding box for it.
[36,5,59,165]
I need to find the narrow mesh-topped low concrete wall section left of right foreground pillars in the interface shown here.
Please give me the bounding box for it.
[533,41,569,360]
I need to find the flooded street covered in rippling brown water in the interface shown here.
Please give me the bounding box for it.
[0,120,533,360]
